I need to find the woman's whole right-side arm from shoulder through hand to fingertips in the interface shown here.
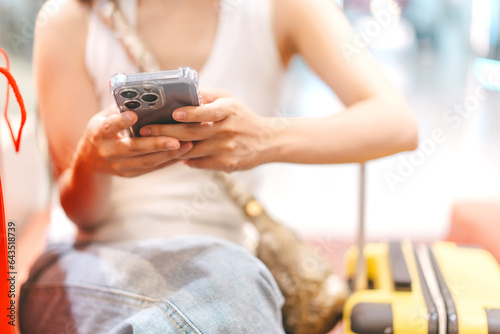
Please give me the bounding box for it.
[145,0,417,171]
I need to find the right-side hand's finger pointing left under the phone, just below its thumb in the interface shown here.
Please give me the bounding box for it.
[140,122,220,141]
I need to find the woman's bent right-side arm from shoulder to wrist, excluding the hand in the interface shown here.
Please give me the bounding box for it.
[273,0,418,163]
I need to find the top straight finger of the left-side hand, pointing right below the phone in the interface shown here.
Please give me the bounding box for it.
[100,136,181,157]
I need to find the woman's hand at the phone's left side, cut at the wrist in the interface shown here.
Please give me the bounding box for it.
[76,107,193,177]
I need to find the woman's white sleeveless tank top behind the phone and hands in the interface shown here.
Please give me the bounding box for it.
[67,0,285,243]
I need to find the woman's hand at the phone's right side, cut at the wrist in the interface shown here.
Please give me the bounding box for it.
[140,90,276,172]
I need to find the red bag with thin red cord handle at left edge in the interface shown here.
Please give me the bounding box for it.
[0,48,26,334]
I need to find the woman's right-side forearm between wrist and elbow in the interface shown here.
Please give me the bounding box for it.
[268,98,418,164]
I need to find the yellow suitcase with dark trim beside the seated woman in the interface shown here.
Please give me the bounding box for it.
[343,242,500,334]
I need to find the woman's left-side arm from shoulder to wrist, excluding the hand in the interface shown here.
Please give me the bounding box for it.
[33,1,110,227]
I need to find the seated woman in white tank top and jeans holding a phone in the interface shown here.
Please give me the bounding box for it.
[21,0,417,333]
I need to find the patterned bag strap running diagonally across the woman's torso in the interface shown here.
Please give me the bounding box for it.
[98,0,272,228]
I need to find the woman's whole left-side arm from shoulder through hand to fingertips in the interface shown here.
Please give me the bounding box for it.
[33,0,192,229]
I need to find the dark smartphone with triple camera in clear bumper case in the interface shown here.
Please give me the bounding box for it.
[109,67,201,137]
